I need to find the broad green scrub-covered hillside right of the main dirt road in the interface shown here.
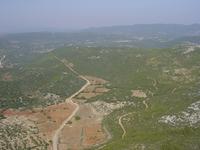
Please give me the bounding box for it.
[53,47,200,150]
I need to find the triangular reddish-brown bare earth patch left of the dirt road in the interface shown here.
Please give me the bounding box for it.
[3,103,75,145]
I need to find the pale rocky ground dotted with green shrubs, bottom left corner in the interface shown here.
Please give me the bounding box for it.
[0,118,49,150]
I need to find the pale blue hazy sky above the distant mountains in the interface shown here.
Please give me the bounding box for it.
[0,0,200,32]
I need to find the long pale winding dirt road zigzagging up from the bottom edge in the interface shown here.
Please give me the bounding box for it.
[52,56,91,150]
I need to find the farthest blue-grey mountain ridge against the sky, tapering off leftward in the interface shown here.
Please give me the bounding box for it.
[83,24,200,37]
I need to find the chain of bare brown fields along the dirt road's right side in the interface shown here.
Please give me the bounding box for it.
[58,76,109,150]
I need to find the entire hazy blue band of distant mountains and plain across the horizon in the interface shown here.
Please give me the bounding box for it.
[0,24,200,51]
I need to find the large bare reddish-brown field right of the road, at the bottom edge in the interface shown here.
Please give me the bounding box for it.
[59,104,107,150]
